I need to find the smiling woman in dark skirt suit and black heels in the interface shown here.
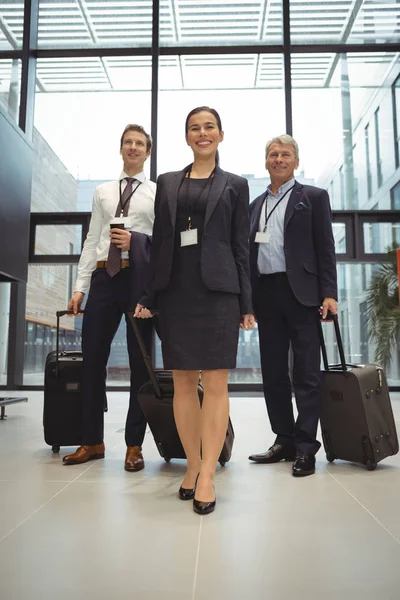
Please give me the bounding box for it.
[135,106,254,514]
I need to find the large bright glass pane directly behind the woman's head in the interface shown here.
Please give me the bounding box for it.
[157,55,285,178]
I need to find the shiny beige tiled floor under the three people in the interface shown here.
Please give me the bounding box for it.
[0,392,400,600]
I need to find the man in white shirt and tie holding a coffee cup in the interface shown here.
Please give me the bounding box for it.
[63,125,156,471]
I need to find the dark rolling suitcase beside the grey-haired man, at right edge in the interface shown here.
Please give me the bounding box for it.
[319,315,399,471]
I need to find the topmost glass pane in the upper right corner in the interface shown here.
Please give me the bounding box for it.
[290,0,400,44]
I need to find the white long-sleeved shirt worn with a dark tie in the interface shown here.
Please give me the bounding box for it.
[75,171,156,293]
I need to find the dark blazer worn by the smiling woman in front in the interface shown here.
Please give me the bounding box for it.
[140,167,253,314]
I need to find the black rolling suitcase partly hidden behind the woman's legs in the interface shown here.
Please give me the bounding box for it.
[127,313,235,466]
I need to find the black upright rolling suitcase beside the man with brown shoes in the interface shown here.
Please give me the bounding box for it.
[43,310,107,452]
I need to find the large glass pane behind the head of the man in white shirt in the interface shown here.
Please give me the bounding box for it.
[32,57,151,212]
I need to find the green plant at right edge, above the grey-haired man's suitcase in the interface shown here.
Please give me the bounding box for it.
[367,242,400,368]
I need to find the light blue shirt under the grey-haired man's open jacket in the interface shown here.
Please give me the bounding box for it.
[257,177,295,275]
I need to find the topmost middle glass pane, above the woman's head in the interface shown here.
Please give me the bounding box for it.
[160,0,282,46]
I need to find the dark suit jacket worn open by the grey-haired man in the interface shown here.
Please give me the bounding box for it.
[250,181,337,311]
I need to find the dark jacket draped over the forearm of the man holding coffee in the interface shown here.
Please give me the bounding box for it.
[129,231,151,309]
